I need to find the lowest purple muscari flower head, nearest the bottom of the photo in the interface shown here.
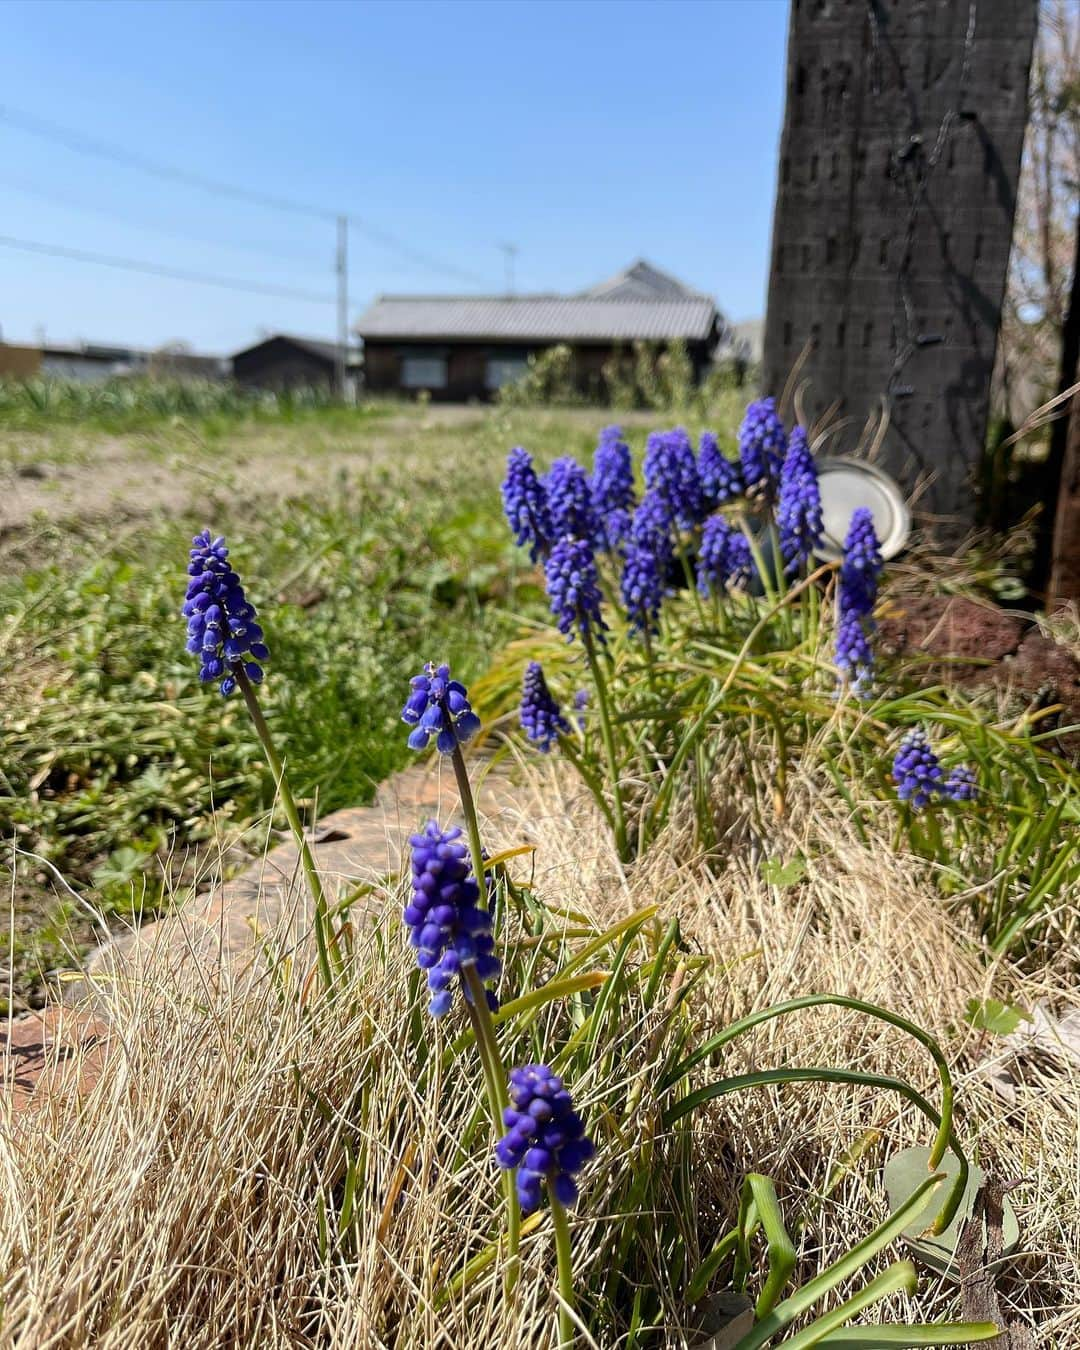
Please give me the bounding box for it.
[495,1064,595,1212]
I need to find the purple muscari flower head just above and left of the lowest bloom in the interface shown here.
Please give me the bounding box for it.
[404,821,502,1017]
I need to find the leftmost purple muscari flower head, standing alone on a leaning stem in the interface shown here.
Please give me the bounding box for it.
[182,529,270,695]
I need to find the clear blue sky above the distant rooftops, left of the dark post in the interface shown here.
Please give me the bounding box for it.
[0,0,787,352]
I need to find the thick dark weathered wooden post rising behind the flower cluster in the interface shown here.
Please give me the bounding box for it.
[763,0,1038,521]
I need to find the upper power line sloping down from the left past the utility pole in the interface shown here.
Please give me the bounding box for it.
[0,104,487,286]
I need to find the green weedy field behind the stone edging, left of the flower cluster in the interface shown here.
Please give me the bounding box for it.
[0,401,734,1007]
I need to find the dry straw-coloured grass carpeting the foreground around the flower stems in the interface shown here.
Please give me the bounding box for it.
[0,767,1080,1350]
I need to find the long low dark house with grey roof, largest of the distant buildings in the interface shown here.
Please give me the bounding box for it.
[356,262,726,402]
